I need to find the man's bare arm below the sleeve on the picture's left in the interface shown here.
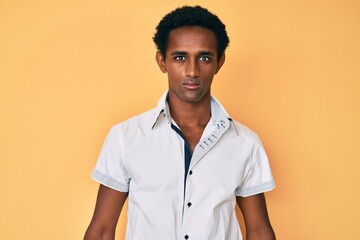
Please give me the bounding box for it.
[84,184,128,240]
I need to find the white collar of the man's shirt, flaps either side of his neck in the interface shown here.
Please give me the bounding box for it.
[151,91,236,134]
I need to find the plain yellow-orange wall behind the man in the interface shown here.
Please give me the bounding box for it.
[0,0,360,240]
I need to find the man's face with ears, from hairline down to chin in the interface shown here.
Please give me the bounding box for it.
[156,27,225,103]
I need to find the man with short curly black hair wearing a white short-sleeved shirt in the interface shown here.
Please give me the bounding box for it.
[85,6,275,240]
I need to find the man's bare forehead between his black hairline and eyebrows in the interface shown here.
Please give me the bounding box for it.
[167,26,217,54]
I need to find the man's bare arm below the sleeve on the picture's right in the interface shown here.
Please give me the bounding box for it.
[236,193,275,240]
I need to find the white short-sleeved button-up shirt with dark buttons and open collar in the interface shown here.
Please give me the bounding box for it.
[91,94,275,240]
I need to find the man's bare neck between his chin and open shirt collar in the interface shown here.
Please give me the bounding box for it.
[168,94,211,128]
